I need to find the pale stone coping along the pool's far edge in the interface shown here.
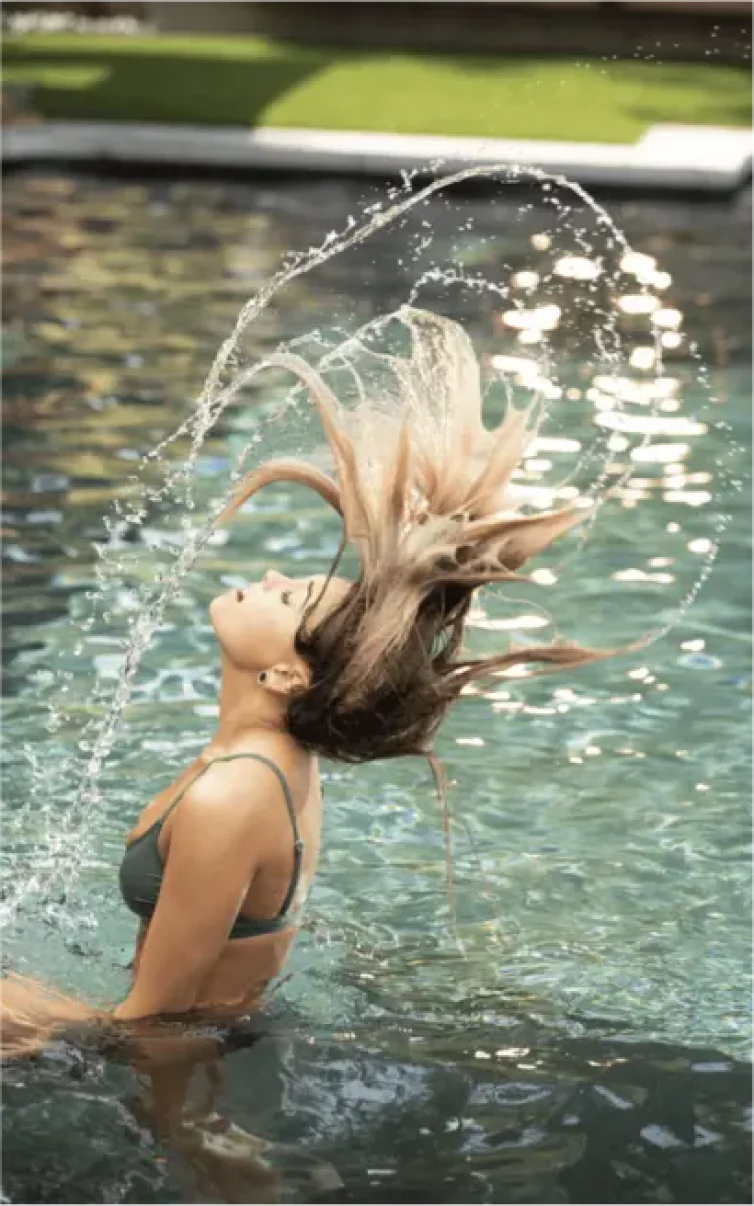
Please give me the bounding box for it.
[0,121,754,194]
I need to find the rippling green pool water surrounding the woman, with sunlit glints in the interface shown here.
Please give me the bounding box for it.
[0,174,754,1206]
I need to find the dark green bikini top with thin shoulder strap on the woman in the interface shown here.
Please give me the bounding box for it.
[119,754,304,938]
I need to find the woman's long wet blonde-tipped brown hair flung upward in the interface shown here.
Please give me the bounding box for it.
[220,308,609,778]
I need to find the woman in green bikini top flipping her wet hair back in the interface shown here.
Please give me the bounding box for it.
[0,310,612,1050]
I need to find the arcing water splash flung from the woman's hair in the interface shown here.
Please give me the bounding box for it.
[0,166,738,924]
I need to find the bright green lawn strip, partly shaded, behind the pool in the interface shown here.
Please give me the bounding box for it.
[0,35,754,142]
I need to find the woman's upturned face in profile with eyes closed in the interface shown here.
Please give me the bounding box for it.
[210,569,350,672]
